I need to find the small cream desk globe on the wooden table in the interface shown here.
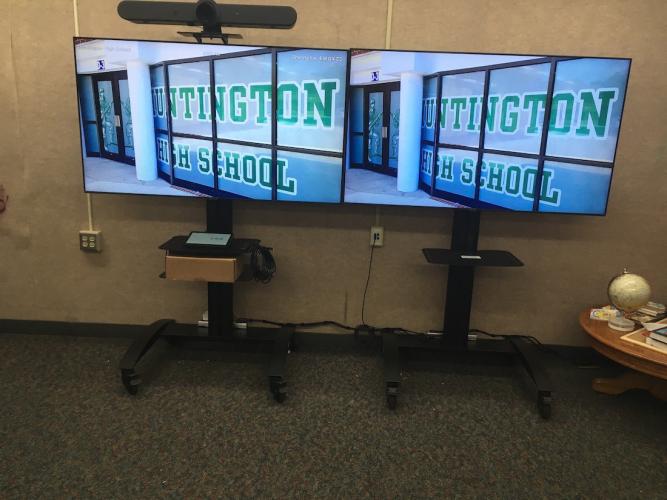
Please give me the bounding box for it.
[607,269,651,332]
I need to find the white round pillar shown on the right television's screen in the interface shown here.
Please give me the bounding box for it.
[396,71,424,193]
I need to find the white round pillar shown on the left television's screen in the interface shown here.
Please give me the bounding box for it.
[127,60,157,181]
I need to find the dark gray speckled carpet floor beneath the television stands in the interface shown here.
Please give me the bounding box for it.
[0,335,667,499]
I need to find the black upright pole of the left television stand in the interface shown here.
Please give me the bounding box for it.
[206,199,234,336]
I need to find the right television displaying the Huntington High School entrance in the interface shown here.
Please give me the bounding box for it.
[344,50,630,215]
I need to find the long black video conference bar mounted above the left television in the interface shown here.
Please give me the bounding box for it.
[118,0,296,44]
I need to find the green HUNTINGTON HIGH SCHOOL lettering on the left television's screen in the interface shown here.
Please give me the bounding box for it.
[152,79,343,196]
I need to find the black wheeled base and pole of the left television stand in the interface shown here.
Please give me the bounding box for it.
[120,199,294,403]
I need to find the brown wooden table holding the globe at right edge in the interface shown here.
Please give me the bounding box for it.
[579,309,667,401]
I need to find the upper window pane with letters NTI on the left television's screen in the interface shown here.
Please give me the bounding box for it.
[167,61,212,137]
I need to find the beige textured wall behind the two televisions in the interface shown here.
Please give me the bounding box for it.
[0,0,667,344]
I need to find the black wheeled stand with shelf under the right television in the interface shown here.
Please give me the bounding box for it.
[382,210,552,419]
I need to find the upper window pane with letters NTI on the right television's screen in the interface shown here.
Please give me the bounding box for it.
[439,71,484,147]
